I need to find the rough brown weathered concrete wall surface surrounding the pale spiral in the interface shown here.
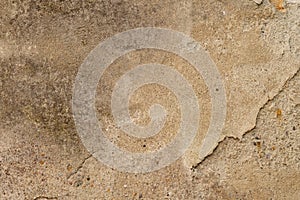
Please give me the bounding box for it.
[0,0,300,199]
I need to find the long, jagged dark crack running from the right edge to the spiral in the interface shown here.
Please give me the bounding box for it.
[191,67,300,171]
